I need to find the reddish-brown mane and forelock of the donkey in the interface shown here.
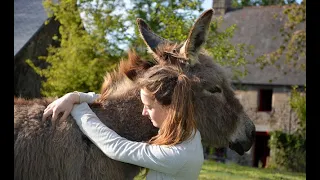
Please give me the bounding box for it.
[98,42,208,103]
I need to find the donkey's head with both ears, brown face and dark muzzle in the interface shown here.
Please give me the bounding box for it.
[137,9,255,155]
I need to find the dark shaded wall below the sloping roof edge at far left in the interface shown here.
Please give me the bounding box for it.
[14,19,60,98]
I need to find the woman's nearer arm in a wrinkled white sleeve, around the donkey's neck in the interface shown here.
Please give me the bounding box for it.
[71,103,187,174]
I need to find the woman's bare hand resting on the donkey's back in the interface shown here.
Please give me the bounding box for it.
[42,93,80,122]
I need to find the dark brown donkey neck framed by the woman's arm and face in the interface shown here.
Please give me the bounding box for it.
[90,91,158,141]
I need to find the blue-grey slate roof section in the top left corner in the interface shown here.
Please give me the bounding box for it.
[14,0,48,55]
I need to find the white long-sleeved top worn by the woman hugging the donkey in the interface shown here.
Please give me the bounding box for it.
[71,93,204,180]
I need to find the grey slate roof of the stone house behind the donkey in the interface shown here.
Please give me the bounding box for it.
[216,6,306,85]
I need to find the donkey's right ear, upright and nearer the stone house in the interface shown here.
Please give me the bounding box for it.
[180,9,213,65]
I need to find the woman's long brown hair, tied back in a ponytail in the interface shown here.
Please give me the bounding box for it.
[138,65,196,145]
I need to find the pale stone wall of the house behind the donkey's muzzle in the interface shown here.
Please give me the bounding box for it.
[227,85,298,166]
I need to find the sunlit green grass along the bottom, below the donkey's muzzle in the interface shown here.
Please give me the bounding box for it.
[134,160,306,180]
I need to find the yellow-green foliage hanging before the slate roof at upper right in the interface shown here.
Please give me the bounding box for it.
[256,0,306,74]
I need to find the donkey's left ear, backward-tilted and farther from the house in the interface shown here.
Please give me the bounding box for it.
[137,18,168,53]
